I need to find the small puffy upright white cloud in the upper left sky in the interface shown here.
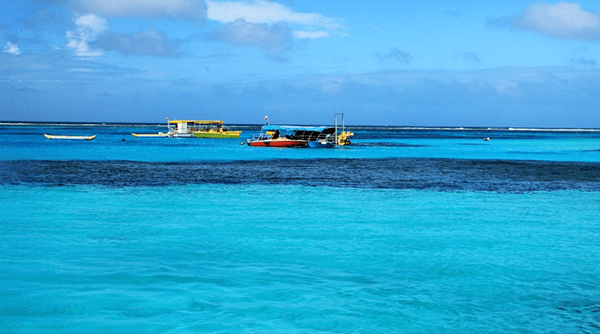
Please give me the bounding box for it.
[67,14,108,57]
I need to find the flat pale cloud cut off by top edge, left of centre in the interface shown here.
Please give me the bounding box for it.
[71,0,206,19]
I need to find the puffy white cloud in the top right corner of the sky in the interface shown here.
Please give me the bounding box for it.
[512,2,600,40]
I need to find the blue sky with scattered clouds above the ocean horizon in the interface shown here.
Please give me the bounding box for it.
[0,0,600,128]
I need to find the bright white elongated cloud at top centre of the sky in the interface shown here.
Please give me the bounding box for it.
[206,0,343,38]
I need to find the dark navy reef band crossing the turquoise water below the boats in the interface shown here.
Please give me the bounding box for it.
[0,158,600,193]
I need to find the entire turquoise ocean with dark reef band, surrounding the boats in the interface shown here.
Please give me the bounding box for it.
[0,123,600,333]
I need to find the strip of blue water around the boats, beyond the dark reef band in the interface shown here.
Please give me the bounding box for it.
[0,126,600,162]
